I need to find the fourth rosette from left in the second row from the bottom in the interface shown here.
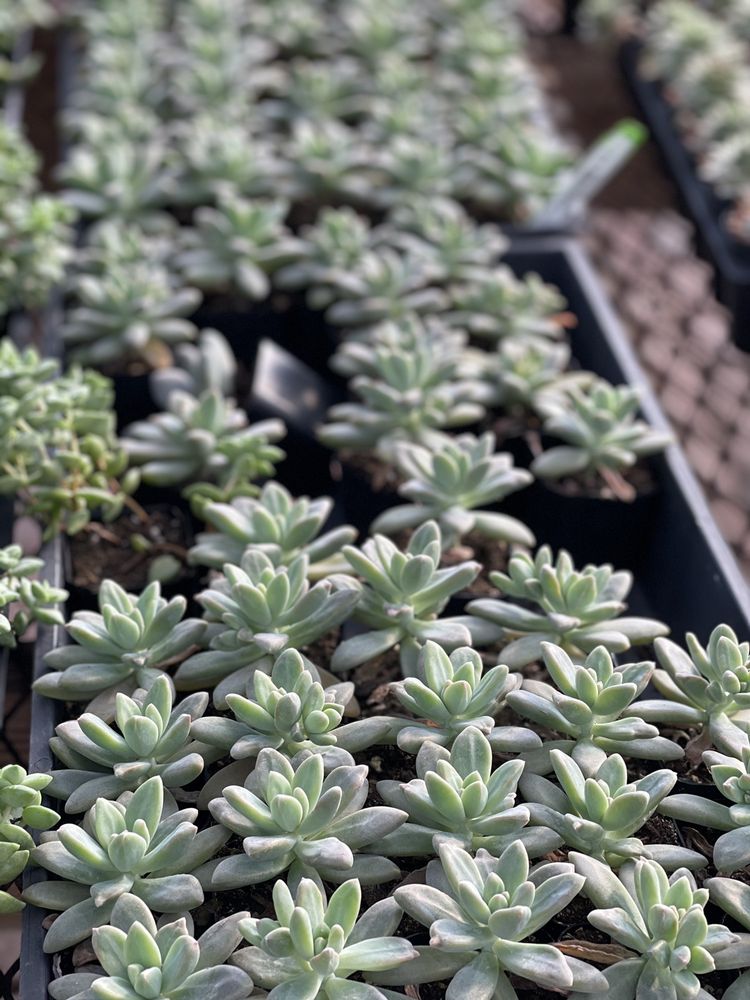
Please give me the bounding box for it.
[519,749,706,870]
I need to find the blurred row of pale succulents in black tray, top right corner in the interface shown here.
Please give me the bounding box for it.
[579,0,750,346]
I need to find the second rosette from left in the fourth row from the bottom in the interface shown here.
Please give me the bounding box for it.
[175,549,359,709]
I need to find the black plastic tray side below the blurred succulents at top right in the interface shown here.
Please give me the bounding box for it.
[619,41,750,351]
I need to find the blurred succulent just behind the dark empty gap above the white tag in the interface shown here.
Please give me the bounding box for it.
[176,192,302,300]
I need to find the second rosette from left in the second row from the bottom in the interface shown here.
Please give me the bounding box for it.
[198,748,407,889]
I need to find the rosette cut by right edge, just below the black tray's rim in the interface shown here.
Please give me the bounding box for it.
[629,625,750,750]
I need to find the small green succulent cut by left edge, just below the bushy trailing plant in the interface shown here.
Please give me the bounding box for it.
[0,545,68,648]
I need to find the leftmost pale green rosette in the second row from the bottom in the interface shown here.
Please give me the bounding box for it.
[23,776,229,953]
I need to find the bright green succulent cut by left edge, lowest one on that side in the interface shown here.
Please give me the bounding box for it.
[0,764,60,914]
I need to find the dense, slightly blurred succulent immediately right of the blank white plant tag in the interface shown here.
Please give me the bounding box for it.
[318,318,484,461]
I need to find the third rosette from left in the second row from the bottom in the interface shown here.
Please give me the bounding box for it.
[375,726,561,857]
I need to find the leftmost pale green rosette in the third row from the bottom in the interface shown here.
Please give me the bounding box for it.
[48,674,219,813]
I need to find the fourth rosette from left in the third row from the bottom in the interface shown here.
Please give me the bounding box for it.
[507,642,683,775]
